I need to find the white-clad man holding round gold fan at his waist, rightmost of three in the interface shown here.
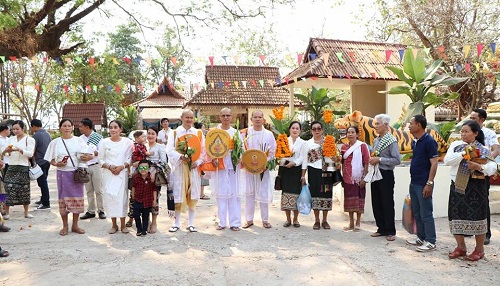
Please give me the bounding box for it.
[243,110,276,228]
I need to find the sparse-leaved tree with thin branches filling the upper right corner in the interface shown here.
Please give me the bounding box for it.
[364,0,500,117]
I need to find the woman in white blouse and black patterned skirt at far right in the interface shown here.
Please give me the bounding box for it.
[444,120,497,261]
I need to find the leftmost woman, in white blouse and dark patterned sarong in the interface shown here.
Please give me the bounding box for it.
[2,120,35,219]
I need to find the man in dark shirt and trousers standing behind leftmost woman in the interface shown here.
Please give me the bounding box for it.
[31,119,52,210]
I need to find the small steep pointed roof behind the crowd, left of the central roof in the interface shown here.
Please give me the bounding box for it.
[132,77,186,107]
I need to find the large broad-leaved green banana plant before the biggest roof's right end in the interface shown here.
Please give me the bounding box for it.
[381,49,469,122]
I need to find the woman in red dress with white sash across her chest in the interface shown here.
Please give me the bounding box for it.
[340,126,370,231]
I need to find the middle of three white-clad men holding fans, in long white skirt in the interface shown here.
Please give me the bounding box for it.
[211,108,241,231]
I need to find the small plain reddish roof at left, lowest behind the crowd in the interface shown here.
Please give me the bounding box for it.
[62,103,107,126]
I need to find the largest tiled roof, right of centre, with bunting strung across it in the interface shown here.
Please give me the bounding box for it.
[281,38,406,85]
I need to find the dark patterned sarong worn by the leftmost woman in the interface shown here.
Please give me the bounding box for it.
[4,165,30,206]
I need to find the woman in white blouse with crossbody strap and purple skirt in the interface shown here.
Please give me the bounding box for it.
[44,118,94,236]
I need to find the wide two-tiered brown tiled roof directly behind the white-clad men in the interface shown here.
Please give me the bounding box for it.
[184,66,302,106]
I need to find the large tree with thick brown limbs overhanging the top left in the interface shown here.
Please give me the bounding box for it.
[0,0,292,58]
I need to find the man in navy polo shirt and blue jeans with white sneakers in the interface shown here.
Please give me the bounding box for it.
[406,115,438,252]
